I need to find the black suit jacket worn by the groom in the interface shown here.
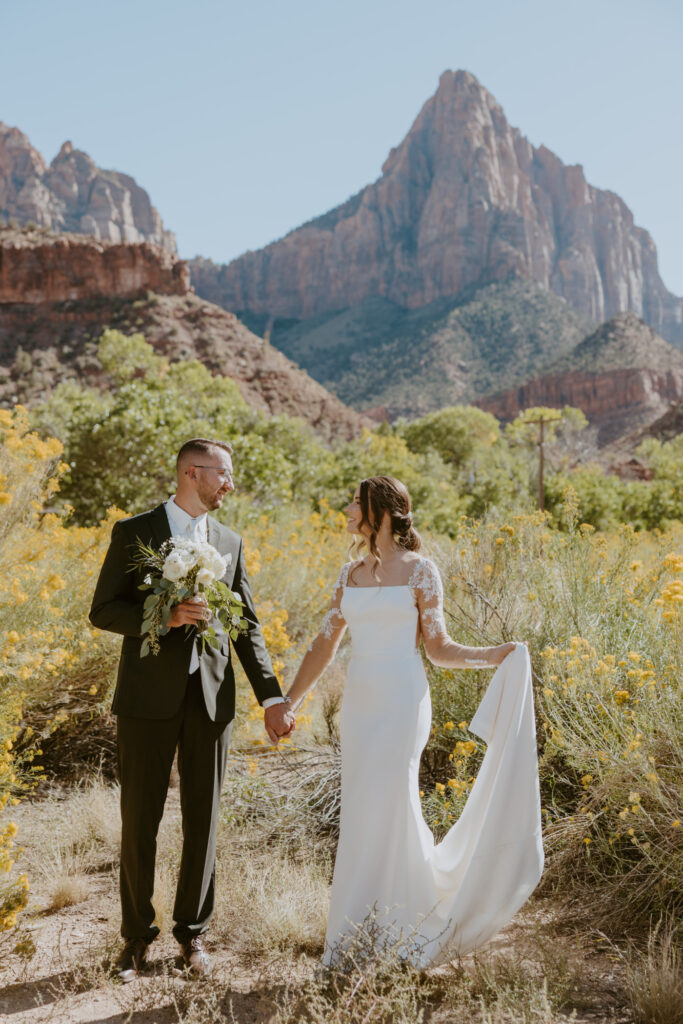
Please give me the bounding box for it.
[90,504,282,722]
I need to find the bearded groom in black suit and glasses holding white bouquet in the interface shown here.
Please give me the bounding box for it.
[90,437,294,981]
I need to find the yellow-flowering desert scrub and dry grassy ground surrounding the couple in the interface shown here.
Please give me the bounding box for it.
[0,409,683,1024]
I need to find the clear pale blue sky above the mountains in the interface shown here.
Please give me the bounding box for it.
[0,0,683,295]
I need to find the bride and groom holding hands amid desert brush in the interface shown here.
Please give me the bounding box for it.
[90,438,543,981]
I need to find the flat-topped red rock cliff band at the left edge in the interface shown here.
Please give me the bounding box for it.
[0,228,189,303]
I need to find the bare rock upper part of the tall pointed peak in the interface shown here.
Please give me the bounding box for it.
[190,71,683,345]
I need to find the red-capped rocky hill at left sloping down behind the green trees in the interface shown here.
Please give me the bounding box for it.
[0,231,370,439]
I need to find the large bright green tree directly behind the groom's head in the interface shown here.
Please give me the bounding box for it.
[35,331,329,523]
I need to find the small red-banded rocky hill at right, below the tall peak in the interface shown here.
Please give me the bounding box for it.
[476,313,683,444]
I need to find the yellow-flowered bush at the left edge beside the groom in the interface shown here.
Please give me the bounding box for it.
[0,407,117,933]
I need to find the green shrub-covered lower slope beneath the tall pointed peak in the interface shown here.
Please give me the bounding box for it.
[248,281,590,419]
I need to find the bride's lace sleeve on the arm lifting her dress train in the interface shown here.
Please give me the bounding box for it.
[409,558,496,669]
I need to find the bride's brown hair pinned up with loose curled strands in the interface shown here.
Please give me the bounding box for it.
[351,476,422,580]
